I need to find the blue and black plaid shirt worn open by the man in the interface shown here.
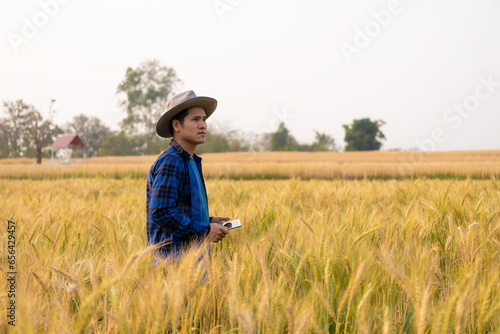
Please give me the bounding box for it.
[147,139,211,257]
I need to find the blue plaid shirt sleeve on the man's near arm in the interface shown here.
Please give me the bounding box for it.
[148,156,210,242]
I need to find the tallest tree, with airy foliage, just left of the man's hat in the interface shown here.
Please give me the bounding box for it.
[117,59,180,154]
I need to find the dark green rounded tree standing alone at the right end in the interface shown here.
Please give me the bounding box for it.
[343,118,385,151]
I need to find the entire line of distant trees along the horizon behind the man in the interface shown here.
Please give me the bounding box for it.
[0,60,385,163]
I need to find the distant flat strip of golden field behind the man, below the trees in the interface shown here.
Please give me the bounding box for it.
[0,151,500,180]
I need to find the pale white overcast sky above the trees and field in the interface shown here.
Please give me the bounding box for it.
[0,0,500,150]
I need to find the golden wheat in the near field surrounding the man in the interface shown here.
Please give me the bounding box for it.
[0,176,500,333]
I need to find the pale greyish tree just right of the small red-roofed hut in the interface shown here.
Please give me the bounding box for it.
[65,114,111,157]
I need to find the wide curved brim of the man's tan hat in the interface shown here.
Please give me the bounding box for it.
[156,96,217,138]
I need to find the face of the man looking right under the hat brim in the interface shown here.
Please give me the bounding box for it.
[172,107,207,145]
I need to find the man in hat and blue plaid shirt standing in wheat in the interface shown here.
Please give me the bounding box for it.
[147,90,229,262]
